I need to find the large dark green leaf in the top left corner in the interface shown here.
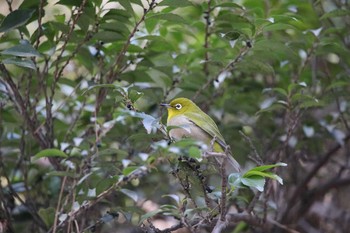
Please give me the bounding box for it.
[0,10,35,32]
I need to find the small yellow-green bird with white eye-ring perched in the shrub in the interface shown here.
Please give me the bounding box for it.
[161,98,241,174]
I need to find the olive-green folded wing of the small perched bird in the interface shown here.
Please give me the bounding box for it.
[184,109,227,148]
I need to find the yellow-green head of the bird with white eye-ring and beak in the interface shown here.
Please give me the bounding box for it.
[161,98,198,119]
